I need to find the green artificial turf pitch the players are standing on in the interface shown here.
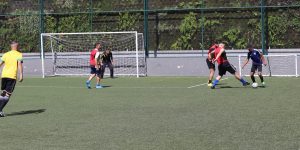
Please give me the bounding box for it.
[0,77,300,150]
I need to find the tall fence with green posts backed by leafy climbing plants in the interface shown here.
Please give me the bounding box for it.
[0,0,300,52]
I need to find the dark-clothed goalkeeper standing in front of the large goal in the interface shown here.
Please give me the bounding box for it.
[101,49,114,79]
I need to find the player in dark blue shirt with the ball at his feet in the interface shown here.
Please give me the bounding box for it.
[242,45,267,86]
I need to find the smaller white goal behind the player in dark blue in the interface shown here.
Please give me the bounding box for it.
[239,54,299,77]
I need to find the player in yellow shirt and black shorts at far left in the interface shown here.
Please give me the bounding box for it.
[0,42,23,117]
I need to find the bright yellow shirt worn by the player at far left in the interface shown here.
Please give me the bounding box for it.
[1,50,23,79]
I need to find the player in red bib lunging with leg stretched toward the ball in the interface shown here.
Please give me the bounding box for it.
[211,43,249,89]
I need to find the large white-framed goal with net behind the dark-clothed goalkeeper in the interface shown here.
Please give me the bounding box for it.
[41,31,146,77]
